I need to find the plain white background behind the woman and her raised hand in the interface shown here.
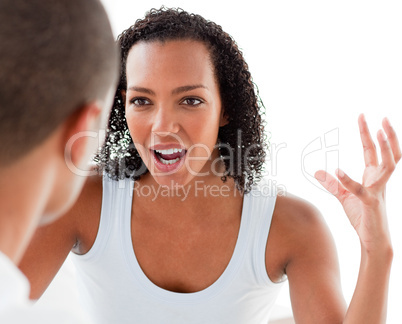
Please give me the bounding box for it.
[38,0,402,324]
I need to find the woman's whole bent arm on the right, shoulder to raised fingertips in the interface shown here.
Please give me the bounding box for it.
[267,116,401,324]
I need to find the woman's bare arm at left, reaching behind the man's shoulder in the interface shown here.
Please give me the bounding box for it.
[19,176,102,299]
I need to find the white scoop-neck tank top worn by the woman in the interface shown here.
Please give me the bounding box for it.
[73,176,282,324]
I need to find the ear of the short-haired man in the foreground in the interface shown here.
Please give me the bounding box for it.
[63,102,102,168]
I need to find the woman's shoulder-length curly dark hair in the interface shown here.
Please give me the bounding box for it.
[95,7,266,192]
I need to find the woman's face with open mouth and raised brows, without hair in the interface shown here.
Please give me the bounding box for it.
[125,40,226,188]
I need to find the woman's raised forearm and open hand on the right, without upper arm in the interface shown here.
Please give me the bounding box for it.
[316,115,401,323]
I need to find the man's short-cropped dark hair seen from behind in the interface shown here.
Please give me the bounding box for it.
[0,0,118,165]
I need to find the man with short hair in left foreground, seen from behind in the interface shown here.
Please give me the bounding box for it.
[0,0,118,323]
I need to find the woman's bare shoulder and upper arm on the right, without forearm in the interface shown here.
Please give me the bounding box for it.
[272,193,346,324]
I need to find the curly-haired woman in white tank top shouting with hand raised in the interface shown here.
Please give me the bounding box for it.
[22,9,401,323]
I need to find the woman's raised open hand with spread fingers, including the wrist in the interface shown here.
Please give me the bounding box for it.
[315,114,401,252]
